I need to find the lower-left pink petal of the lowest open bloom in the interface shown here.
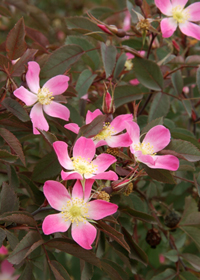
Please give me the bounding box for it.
[42,213,71,235]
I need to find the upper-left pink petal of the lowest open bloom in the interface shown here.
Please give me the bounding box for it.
[43,180,71,211]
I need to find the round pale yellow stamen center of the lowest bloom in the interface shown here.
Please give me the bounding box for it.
[61,197,89,225]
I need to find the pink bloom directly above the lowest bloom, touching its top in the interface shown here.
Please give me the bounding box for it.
[53,137,118,180]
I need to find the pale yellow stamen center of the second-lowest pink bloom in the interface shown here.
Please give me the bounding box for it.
[71,156,97,175]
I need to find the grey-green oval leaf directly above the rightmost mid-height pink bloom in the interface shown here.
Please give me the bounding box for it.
[149,92,170,122]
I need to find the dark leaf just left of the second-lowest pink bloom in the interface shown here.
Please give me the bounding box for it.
[32,151,61,182]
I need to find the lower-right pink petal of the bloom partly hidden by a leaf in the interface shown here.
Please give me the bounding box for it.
[106,133,132,148]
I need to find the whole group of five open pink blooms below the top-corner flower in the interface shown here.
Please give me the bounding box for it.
[14,61,179,249]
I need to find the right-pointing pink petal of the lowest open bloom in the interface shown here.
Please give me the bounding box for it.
[87,199,118,220]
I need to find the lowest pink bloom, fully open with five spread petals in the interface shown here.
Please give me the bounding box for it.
[42,179,118,250]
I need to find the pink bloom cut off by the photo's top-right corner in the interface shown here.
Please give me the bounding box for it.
[155,0,200,40]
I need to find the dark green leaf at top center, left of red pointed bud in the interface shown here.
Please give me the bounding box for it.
[66,16,106,42]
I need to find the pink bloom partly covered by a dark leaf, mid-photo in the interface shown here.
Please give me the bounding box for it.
[65,109,133,148]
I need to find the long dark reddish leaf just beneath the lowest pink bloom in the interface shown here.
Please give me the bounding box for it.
[45,238,101,267]
